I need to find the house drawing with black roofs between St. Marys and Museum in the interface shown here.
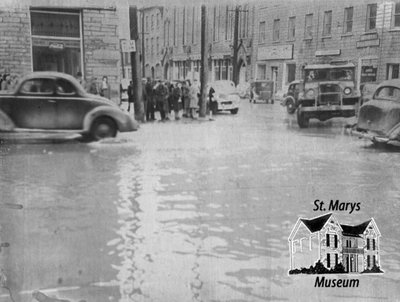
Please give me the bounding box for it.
[289,213,381,273]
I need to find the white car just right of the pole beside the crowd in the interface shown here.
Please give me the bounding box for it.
[207,80,240,114]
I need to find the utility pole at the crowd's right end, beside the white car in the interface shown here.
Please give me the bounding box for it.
[199,4,208,117]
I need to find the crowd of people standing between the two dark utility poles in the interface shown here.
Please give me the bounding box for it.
[140,78,200,121]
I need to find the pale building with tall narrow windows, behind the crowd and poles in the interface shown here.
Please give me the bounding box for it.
[142,2,255,82]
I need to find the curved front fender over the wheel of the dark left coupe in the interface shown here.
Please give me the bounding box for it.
[83,106,139,132]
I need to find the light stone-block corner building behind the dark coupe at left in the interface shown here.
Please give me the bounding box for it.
[0,0,129,99]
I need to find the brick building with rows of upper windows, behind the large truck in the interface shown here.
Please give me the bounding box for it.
[254,0,400,93]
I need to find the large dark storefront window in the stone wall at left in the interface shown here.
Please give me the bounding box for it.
[30,10,84,76]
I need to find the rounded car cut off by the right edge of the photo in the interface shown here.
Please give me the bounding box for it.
[353,79,400,146]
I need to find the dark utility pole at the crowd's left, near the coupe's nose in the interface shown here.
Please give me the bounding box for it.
[129,6,144,122]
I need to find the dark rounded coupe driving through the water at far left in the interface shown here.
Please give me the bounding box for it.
[0,72,139,140]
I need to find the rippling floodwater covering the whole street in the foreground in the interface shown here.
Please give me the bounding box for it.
[0,100,400,302]
